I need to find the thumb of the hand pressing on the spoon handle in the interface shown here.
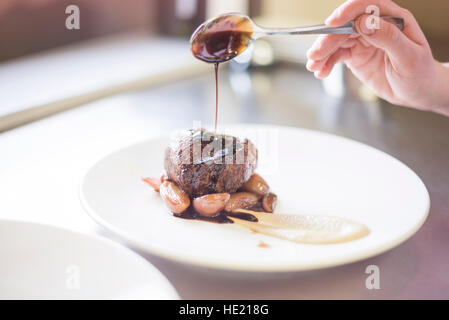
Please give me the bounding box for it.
[355,14,419,66]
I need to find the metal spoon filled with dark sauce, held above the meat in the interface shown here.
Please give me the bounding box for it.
[190,13,404,63]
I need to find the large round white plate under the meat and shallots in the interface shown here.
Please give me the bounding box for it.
[80,125,430,272]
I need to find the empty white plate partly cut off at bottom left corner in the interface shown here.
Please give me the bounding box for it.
[0,220,179,299]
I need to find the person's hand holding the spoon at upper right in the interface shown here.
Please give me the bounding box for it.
[307,0,449,111]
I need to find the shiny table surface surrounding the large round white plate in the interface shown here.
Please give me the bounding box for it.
[0,66,449,299]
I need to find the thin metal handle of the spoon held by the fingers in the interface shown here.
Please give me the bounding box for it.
[262,16,404,35]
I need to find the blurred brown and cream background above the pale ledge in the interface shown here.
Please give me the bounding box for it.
[0,0,449,61]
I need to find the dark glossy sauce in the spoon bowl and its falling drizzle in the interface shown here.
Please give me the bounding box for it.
[190,14,253,133]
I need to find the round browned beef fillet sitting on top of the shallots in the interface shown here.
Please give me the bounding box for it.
[164,129,257,197]
